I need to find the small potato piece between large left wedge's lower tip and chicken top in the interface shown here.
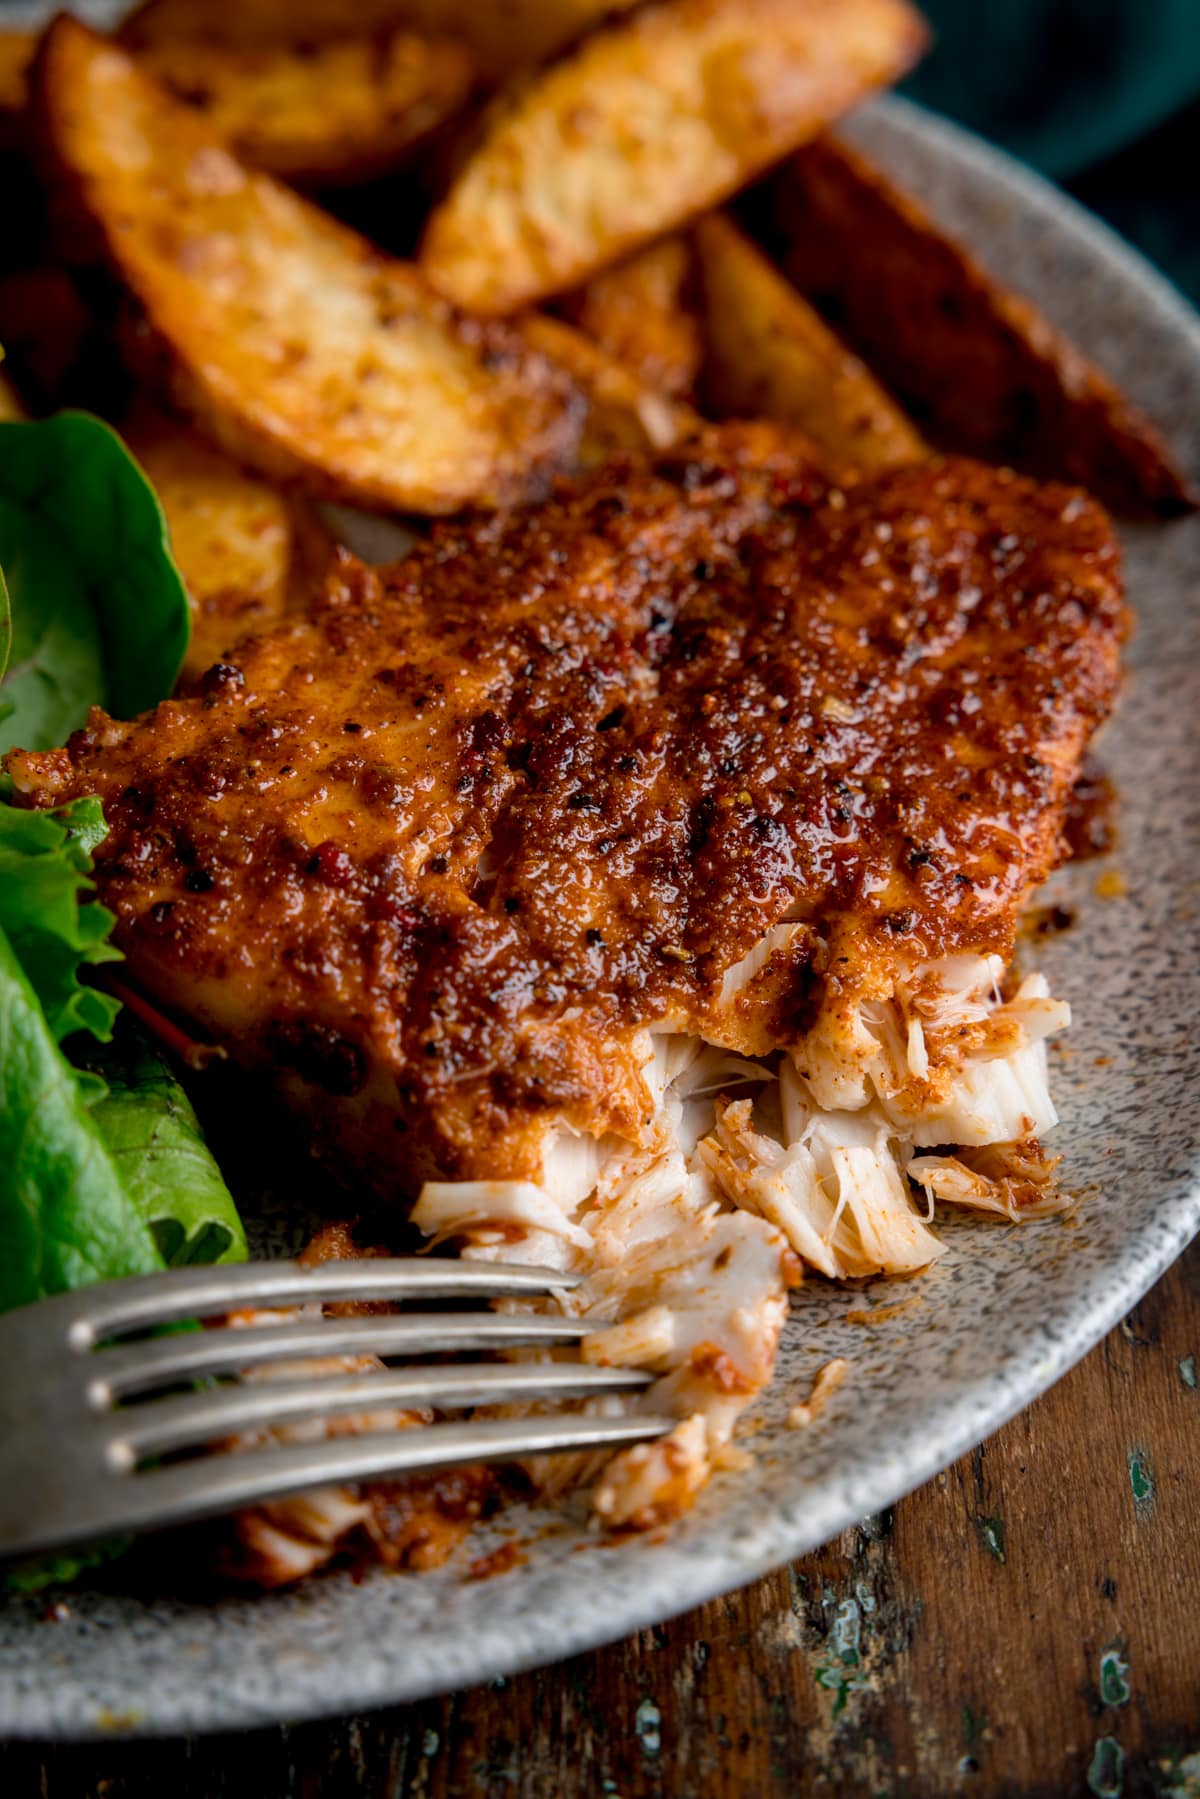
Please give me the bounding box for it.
[524,313,700,468]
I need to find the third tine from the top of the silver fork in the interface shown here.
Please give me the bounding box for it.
[108,1362,653,1466]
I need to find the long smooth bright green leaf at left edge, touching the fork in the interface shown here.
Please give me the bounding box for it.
[0,930,162,1311]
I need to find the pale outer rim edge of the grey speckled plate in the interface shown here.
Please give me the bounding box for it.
[0,95,1200,1741]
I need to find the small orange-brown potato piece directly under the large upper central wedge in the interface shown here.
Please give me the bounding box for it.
[556,237,702,399]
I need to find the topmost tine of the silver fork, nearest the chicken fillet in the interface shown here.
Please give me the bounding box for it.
[70,1256,581,1349]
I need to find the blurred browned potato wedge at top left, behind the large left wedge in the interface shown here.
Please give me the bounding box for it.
[140,31,475,185]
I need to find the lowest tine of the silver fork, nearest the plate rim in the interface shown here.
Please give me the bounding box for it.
[99,1414,678,1529]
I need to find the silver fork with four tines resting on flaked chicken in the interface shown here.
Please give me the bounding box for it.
[0,1258,673,1556]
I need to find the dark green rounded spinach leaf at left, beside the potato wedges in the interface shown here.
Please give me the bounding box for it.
[0,412,189,748]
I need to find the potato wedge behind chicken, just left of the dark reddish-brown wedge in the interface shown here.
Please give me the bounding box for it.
[694,212,927,470]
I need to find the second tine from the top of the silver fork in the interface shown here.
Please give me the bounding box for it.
[86,1311,596,1410]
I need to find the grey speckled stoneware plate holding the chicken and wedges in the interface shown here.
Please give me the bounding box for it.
[0,101,1200,1736]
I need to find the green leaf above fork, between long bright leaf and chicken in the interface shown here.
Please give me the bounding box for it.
[86,1029,246,1266]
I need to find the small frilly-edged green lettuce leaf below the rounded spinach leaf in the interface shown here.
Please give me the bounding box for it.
[0,799,121,1042]
